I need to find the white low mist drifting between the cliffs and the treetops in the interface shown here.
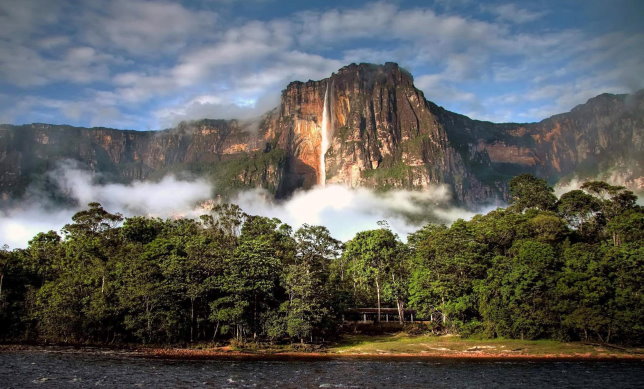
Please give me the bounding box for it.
[0,162,475,248]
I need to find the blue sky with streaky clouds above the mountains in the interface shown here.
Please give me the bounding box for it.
[0,0,644,130]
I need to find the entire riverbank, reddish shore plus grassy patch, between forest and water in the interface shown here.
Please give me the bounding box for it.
[0,333,644,360]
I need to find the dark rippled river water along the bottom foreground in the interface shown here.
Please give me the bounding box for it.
[0,351,644,389]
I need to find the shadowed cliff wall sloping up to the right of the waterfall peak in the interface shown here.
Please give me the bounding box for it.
[438,91,644,191]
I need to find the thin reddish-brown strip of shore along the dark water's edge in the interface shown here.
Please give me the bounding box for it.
[0,344,644,362]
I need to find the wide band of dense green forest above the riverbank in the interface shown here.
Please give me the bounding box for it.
[0,175,644,345]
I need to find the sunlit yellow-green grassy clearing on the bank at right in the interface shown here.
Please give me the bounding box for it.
[328,333,644,357]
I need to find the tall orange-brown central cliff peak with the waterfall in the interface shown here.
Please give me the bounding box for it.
[266,63,500,204]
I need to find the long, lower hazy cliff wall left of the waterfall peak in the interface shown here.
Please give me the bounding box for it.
[0,120,282,202]
